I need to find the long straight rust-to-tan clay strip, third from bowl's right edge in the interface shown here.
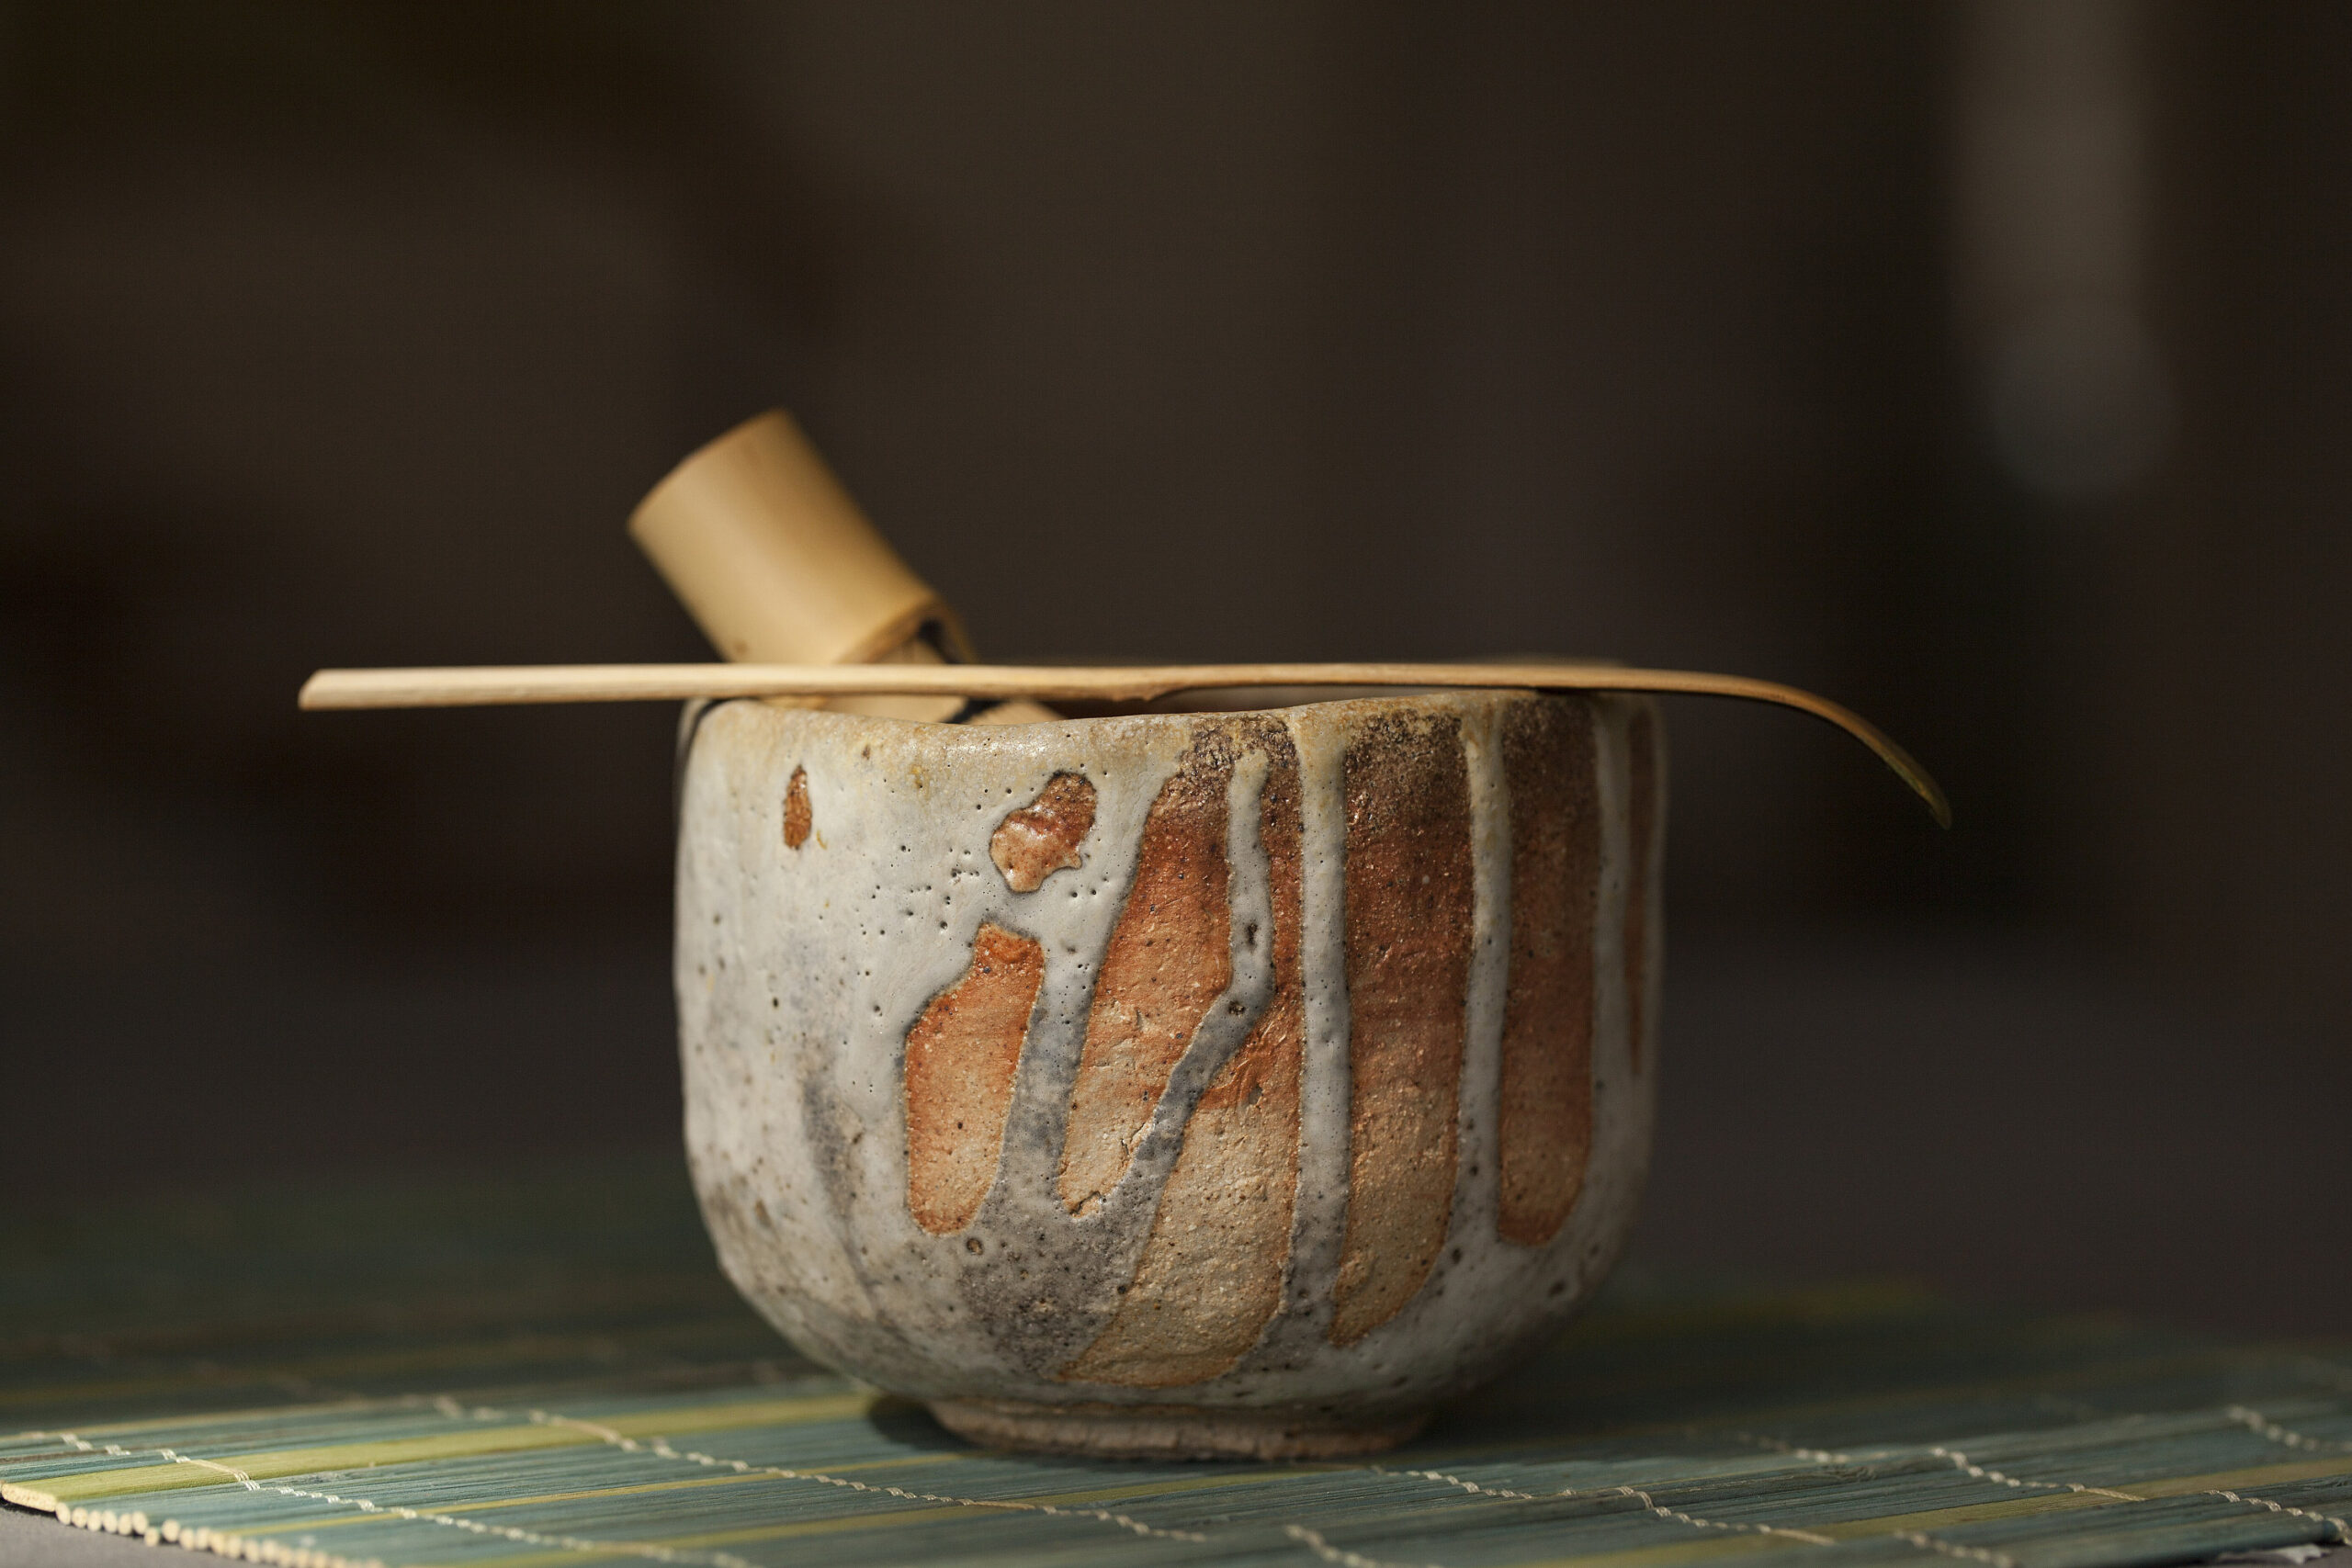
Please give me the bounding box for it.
[1331,717,1473,1345]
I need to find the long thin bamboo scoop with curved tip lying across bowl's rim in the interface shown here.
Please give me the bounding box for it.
[301,660,1952,828]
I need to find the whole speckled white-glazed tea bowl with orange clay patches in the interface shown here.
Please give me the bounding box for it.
[677,691,1665,1458]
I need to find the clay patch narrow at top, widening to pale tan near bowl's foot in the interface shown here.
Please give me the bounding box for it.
[1061,745,1306,1389]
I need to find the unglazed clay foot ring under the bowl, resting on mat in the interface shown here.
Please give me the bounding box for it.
[932,1399,1430,1460]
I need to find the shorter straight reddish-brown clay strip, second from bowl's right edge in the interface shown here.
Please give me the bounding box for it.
[1496,701,1601,1246]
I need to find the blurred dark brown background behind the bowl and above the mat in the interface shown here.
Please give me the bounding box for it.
[0,0,2352,1328]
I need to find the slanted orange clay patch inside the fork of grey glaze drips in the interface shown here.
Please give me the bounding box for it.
[1061,748,1232,1213]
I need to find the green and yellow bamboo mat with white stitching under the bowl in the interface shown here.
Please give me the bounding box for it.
[0,1161,2352,1568]
